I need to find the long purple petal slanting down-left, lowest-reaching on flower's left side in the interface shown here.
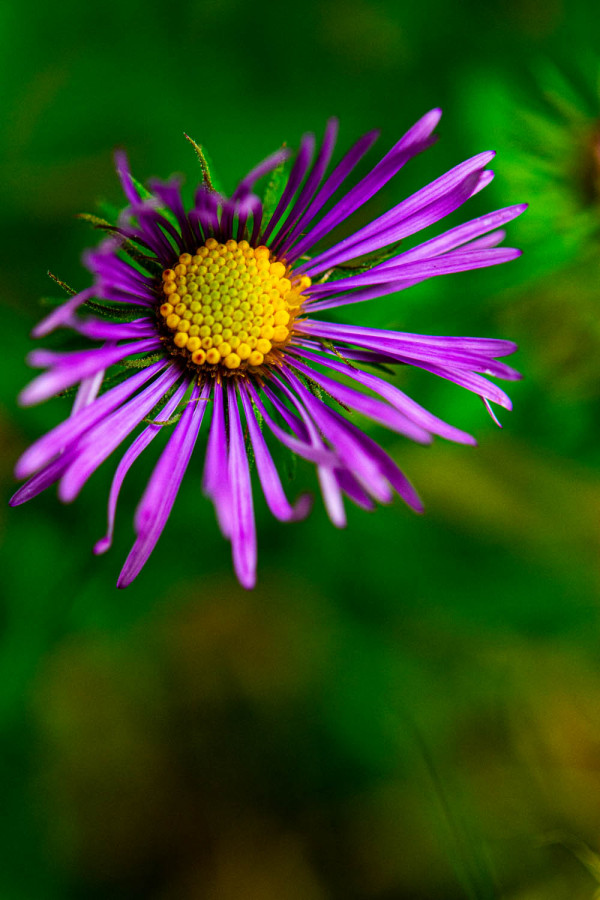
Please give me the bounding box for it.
[117,384,210,588]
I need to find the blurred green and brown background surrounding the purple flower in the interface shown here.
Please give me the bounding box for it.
[0,0,600,900]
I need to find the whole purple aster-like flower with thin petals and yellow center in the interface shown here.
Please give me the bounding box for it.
[11,110,525,588]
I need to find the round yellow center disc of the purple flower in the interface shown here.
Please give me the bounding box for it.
[160,238,311,374]
